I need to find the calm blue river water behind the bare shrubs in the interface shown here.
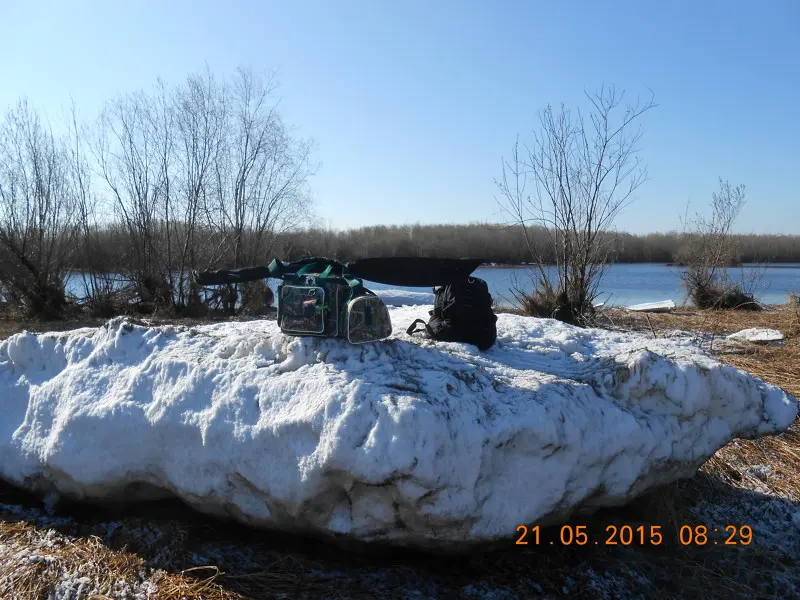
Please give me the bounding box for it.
[67,263,800,306]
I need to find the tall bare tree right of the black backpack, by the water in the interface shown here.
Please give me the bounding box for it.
[496,87,655,324]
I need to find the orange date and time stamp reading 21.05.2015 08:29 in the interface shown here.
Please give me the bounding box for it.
[516,525,753,546]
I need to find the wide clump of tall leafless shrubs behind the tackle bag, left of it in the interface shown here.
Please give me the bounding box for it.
[95,70,314,314]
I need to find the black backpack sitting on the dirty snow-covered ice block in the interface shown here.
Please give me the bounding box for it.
[407,277,497,350]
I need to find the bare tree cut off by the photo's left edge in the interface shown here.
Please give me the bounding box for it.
[0,101,76,318]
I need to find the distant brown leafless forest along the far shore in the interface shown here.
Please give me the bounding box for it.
[72,224,800,271]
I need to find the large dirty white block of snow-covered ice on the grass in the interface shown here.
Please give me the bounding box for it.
[0,306,797,549]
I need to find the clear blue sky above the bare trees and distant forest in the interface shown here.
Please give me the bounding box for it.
[0,0,800,234]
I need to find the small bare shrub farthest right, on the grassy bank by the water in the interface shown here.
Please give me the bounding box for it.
[681,178,761,310]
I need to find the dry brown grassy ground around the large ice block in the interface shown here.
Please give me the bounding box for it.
[0,306,800,600]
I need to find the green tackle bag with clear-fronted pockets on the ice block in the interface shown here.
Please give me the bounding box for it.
[269,258,392,344]
